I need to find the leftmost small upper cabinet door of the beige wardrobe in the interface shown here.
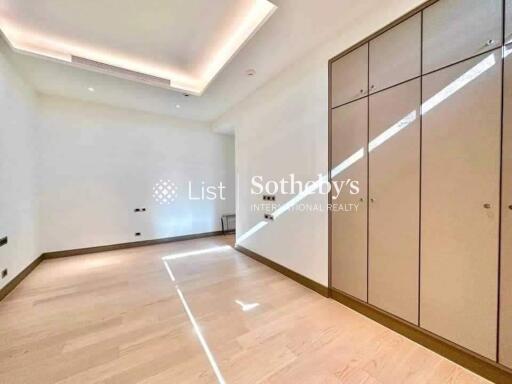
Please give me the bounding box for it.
[331,44,368,107]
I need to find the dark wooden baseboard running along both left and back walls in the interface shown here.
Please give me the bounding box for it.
[0,231,222,300]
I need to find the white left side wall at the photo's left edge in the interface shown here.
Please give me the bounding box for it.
[0,41,39,288]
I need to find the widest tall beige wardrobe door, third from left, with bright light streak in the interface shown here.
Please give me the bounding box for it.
[420,49,501,360]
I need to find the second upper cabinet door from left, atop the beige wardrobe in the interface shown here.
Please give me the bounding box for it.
[370,13,421,93]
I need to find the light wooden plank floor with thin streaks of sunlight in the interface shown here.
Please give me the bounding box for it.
[0,236,486,384]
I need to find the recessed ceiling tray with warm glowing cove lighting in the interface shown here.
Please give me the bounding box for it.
[0,0,276,95]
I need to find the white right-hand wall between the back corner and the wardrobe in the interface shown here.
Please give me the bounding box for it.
[214,0,423,285]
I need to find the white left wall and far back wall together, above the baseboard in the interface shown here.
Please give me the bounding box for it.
[0,41,235,276]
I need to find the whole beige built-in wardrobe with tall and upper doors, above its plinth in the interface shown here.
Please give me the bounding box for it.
[329,0,512,376]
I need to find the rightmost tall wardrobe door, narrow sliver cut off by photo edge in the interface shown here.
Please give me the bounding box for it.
[499,46,512,368]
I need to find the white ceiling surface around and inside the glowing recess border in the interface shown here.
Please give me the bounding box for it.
[0,0,408,122]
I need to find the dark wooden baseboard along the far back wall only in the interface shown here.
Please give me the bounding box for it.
[42,231,222,260]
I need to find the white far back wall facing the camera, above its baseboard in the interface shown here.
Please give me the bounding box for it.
[39,96,235,252]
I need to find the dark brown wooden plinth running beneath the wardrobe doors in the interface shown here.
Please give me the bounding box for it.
[330,288,512,384]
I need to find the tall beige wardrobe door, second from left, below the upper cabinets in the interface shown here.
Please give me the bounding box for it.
[368,79,421,325]
